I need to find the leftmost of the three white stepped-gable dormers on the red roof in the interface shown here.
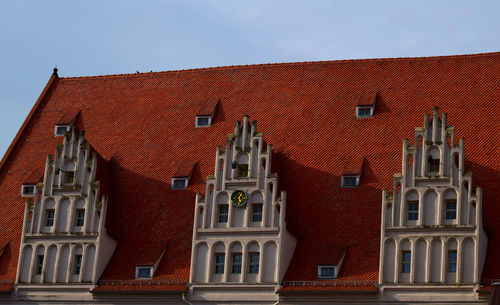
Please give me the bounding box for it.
[15,129,116,297]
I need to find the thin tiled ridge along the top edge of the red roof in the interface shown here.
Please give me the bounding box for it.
[59,51,500,80]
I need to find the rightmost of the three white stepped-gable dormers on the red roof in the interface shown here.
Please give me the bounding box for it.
[379,107,487,302]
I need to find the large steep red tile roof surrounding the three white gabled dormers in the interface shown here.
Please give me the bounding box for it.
[0,53,500,290]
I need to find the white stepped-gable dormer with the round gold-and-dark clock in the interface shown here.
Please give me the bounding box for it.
[188,116,296,303]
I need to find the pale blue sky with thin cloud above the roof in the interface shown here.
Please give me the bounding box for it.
[0,0,500,155]
